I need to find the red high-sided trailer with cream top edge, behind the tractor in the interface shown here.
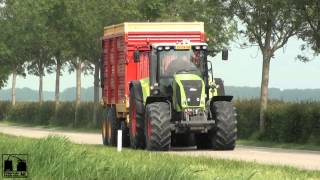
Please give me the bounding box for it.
[102,22,205,118]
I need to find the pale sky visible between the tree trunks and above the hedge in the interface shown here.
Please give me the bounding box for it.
[4,38,320,91]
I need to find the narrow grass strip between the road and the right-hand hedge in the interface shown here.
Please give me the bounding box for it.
[237,139,320,151]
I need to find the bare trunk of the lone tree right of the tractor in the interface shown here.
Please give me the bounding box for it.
[260,52,271,133]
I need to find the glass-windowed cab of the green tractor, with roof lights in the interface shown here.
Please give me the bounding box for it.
[149,41,208,100]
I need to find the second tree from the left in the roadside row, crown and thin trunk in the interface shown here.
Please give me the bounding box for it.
[12,0,53,104]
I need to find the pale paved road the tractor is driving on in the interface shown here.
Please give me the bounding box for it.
[0,124,320,170]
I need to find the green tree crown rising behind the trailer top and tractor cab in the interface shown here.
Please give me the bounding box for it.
[138,0,236,53]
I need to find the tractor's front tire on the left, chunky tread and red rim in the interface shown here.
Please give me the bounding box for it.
[145,102,171,151]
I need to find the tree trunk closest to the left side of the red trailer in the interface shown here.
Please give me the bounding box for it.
[92,60,100,126]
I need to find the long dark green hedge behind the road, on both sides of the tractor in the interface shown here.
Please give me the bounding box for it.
[0,100,320,144]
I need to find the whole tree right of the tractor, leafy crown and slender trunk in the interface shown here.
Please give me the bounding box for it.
[229,0,301,133]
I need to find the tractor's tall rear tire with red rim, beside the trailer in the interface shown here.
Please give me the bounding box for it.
[129,86,145,149]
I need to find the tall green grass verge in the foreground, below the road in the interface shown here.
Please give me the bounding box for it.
[0,134,320,180]
